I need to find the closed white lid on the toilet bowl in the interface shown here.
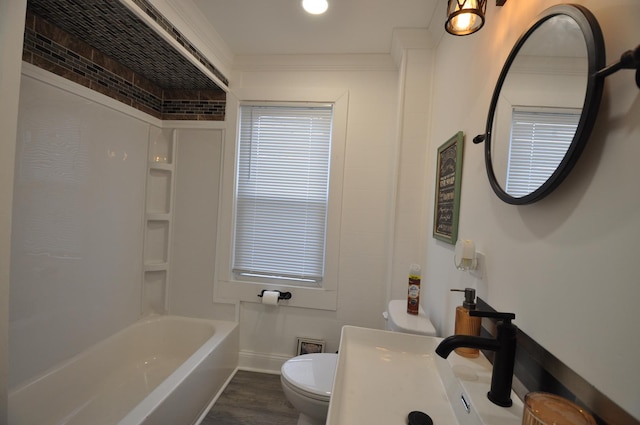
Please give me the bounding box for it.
[281,353,338,400]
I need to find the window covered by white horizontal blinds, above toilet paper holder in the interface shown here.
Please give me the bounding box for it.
[233,105,333,286]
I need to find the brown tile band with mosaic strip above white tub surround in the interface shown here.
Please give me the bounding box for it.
[23,2,226,121]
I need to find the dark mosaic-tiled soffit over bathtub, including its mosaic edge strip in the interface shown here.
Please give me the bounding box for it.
[27,0,228,89]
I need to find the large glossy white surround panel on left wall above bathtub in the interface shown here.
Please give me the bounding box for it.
[9,72,149,388]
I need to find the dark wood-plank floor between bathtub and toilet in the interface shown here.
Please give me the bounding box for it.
[201,370,298,425]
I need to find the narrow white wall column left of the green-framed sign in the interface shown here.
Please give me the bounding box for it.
[386,35,434,305]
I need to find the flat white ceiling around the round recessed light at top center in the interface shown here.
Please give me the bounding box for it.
[192,0,445,55]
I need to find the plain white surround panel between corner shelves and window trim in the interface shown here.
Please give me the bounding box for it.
[169,129,228,320]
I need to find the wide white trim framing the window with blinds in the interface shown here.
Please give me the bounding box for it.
[213,89,349,311]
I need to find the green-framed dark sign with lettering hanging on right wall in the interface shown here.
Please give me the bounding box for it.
[433,131,464,245]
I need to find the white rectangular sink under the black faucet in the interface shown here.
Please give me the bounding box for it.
[327,326,522,425]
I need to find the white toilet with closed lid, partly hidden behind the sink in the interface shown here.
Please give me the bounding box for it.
[280,300,436,425]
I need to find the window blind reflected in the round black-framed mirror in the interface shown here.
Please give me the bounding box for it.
[505,109,580,197]
